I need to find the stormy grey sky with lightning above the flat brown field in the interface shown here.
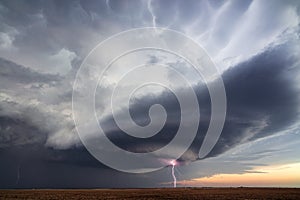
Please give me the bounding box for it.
[0,0,300,188]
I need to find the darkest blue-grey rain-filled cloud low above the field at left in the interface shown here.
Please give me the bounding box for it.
[0,145,166,188]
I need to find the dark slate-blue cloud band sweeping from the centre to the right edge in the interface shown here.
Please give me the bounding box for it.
[102,39,299,162]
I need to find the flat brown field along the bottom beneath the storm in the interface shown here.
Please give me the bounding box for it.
[0,188,300,200]
